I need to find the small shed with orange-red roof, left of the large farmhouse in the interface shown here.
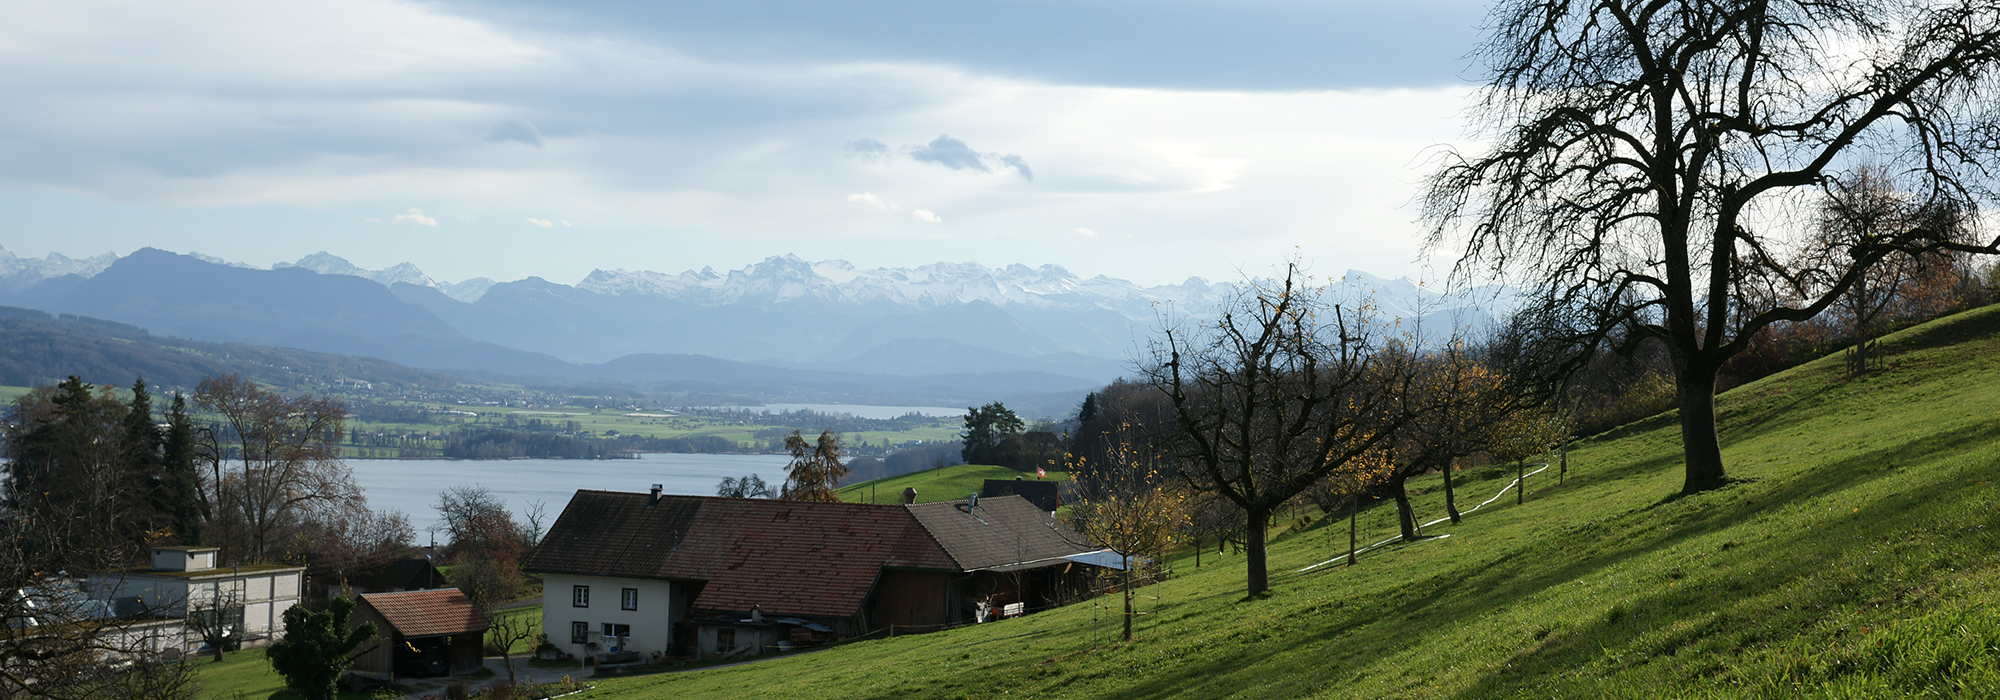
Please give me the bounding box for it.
[348,588,488,680]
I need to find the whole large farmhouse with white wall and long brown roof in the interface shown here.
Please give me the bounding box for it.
[528,486,1096,662]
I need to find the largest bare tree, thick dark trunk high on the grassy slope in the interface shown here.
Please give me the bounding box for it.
[1424,0,2000,492]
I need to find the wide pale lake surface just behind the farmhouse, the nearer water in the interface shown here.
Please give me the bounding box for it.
[346,454,792,544]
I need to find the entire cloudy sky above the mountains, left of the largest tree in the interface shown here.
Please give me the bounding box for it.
[0,0,1484,284]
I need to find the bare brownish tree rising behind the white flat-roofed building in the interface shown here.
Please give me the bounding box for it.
[194,374,360,562]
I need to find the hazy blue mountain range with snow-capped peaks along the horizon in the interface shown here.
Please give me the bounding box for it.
[0,248,1514,390]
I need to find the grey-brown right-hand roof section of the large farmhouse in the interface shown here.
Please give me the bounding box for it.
[904,496,1098,572]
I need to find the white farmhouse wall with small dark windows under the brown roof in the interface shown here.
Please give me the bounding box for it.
[542,574,680,658]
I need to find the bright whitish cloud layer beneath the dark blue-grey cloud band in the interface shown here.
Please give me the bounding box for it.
[0,0,1466,282]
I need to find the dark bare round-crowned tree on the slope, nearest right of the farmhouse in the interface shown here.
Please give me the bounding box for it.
[1144,264,1408,596]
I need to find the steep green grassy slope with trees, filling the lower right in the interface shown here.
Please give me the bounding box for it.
[592,308,2000,698]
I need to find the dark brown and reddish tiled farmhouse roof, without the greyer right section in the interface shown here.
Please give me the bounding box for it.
[528,490,958,618]
